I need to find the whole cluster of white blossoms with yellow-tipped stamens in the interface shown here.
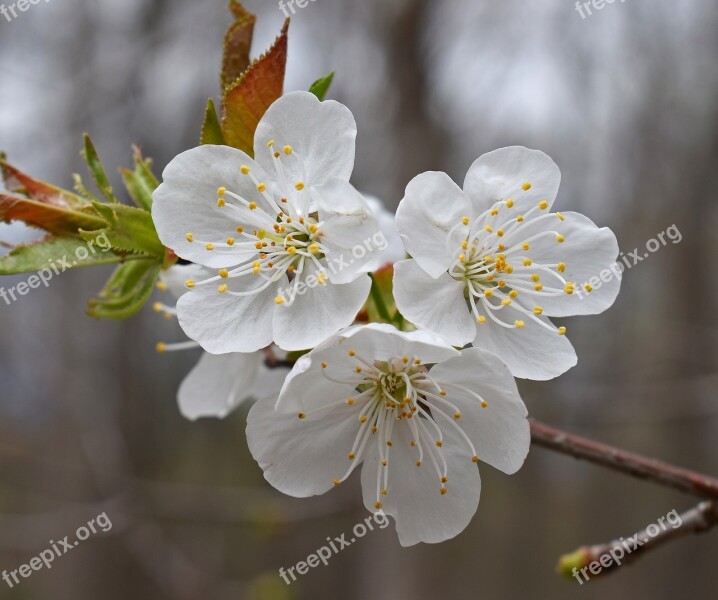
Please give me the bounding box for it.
[152,92,619,545]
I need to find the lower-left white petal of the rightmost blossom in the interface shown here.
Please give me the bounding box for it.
[394,260,476,346]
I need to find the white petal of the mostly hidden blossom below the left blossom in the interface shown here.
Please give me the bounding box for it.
[177,352,262,421]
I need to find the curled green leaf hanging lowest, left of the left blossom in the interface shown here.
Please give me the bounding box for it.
[87,259,161,319]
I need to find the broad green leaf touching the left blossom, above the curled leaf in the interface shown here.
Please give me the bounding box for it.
[80,203,165,262]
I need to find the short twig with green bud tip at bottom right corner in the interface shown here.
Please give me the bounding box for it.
[556,501,718,584]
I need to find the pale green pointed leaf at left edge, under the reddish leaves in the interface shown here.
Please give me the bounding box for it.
[0,236,123,276]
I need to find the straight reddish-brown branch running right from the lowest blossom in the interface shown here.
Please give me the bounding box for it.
[530,419,718,500]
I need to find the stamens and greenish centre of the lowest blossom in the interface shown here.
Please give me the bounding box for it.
[306,350,488,509]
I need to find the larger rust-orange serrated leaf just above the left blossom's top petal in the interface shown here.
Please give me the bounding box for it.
[222,19,289,156]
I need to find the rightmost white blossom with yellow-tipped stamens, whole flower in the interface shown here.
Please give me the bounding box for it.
[394,146,620,380]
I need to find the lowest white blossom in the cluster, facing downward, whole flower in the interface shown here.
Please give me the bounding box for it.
[247,324,530,546]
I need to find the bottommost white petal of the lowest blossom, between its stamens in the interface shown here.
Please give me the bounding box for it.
[362,423,481,546]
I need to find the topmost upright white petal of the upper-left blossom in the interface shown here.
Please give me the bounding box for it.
[254,92,357,187]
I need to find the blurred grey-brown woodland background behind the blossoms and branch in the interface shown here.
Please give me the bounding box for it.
[0,0,718,600]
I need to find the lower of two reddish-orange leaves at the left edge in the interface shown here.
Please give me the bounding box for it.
[0,192,106,235]
